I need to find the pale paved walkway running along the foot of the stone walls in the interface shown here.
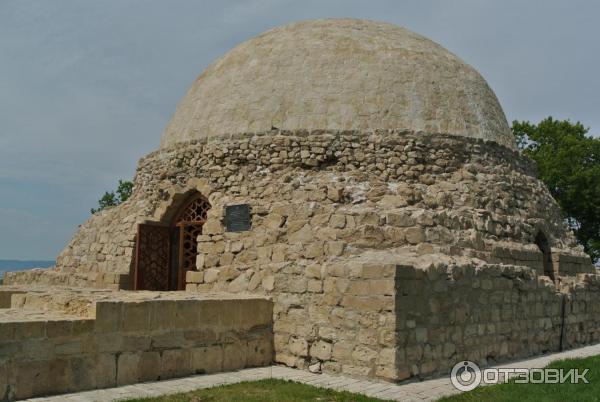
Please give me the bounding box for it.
[29,344,600,402]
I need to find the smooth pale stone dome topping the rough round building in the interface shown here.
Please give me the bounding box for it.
[161,19,515,149]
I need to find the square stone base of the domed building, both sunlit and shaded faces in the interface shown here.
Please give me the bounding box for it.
[188,258,600,381]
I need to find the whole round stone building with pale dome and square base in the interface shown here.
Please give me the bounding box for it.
[5,19,600,390]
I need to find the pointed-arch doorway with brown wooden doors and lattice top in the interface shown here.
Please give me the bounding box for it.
[133,193,211,290]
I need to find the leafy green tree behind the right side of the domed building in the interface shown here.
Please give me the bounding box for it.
[512,117,600,263]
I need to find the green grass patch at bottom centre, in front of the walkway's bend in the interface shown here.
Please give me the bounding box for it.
[128,380,390,402]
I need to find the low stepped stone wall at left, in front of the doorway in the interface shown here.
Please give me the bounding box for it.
[0,292,273,400]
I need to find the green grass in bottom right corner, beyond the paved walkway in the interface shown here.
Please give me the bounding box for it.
[439,356,600,402]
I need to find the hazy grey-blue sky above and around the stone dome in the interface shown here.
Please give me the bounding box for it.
[0,0,600,259]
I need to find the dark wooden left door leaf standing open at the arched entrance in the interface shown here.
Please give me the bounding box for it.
[133,224,171,290]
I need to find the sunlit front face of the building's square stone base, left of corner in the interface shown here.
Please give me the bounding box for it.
[188,260,400,381]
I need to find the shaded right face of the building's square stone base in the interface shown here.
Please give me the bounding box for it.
[395,265,600,378]
